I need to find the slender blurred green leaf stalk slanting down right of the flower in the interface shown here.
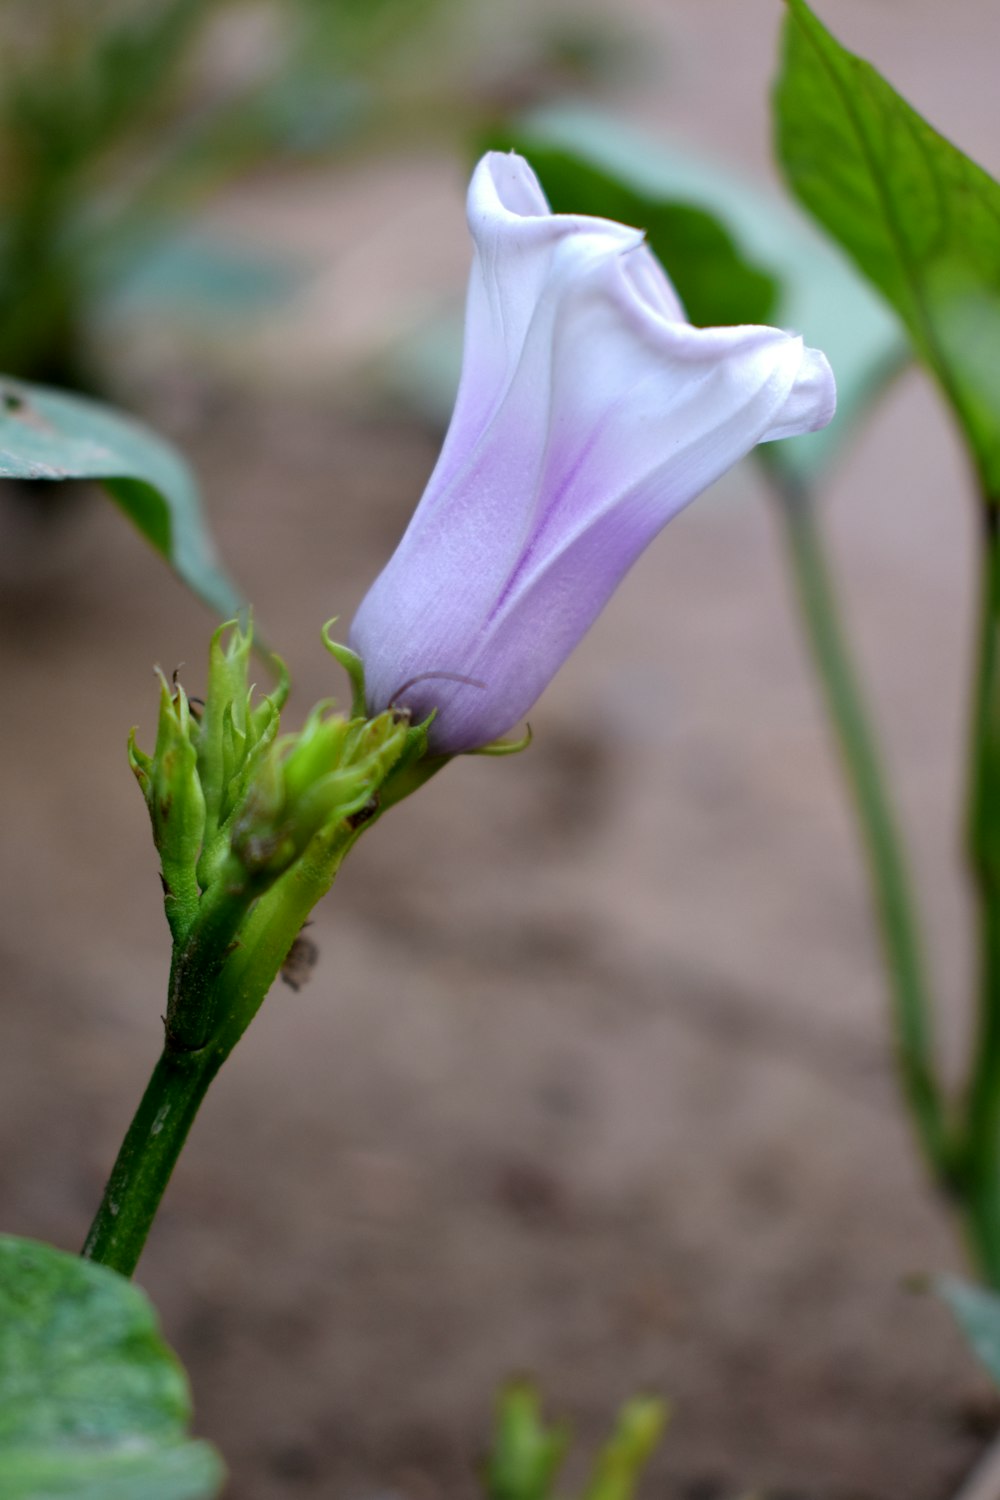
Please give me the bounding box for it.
[768,468,954,1191]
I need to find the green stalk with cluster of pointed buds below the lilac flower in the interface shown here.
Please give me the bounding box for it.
[84,621,431,1275]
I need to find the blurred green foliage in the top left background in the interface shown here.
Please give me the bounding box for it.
[0,0,622,392]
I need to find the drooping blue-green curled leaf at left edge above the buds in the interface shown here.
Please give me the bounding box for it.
[0,377,243,617]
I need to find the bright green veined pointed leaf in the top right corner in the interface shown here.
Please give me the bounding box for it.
[775,0,1000,501]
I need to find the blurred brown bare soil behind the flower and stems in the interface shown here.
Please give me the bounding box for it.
[0,0,1000,1500]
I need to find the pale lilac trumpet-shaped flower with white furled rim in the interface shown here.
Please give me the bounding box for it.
[351,153,835,755]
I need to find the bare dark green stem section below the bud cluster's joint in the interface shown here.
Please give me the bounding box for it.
[82,1044,228,1277]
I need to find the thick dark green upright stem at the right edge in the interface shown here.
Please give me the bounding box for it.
[963,501,1000,1286]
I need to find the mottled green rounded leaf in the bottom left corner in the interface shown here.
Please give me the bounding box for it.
[0,1235,222,1500]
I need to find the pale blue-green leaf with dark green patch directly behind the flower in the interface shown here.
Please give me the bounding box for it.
[490,105,907,480]
